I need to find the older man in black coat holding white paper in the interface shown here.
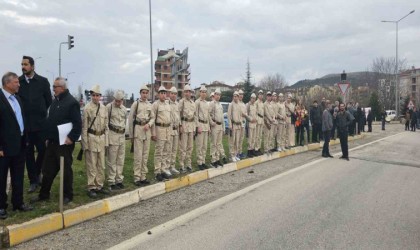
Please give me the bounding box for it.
[32,77,82,204]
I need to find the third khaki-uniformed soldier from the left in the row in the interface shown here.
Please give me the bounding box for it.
[128,85,155,186]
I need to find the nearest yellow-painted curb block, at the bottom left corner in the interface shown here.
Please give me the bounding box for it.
[7,213,63,246]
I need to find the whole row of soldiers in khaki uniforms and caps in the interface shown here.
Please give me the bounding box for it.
[82,82,302,197]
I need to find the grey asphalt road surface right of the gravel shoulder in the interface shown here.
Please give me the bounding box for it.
[110,132,420,249]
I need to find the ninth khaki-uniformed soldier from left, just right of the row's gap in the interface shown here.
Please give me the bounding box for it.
[227,91,242,162]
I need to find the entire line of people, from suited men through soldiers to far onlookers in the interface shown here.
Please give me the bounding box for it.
[0,56,380,219]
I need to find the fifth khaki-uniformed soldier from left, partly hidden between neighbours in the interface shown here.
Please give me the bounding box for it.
[166,87,181,175]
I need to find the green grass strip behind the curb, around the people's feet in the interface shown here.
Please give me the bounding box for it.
[0,135,247,225]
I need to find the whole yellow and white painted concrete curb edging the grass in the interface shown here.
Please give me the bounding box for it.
[5,134,365,247]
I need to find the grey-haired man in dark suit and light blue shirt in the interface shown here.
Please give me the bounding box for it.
[0,72,32,219]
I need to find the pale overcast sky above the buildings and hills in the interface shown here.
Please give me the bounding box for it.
[0,0,420,97]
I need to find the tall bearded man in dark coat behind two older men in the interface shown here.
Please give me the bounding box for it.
[18,56,52,193]
